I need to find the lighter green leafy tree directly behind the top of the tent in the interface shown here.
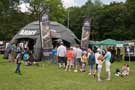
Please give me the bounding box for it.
[30,0,65,23]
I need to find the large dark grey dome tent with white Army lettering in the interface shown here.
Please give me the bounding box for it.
[11,21,79,60]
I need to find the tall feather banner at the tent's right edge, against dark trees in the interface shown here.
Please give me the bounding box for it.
[81,18,91,50]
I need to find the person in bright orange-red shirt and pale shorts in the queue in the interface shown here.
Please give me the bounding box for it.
[65,48,74,71]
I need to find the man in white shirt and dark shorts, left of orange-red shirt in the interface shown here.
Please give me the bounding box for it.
[57,42,66,68]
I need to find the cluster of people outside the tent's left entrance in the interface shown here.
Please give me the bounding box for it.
[7,43,34,74]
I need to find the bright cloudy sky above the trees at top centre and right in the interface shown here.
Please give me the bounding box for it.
[62,0,126,8]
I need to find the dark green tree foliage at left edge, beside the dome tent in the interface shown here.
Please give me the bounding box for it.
[0,0,31,40]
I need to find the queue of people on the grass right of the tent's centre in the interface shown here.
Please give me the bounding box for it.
[52,42,112,81]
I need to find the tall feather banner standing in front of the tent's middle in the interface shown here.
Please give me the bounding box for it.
[40,11,52,57]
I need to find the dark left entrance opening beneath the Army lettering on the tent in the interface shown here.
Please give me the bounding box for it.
[17,38,35,51]
